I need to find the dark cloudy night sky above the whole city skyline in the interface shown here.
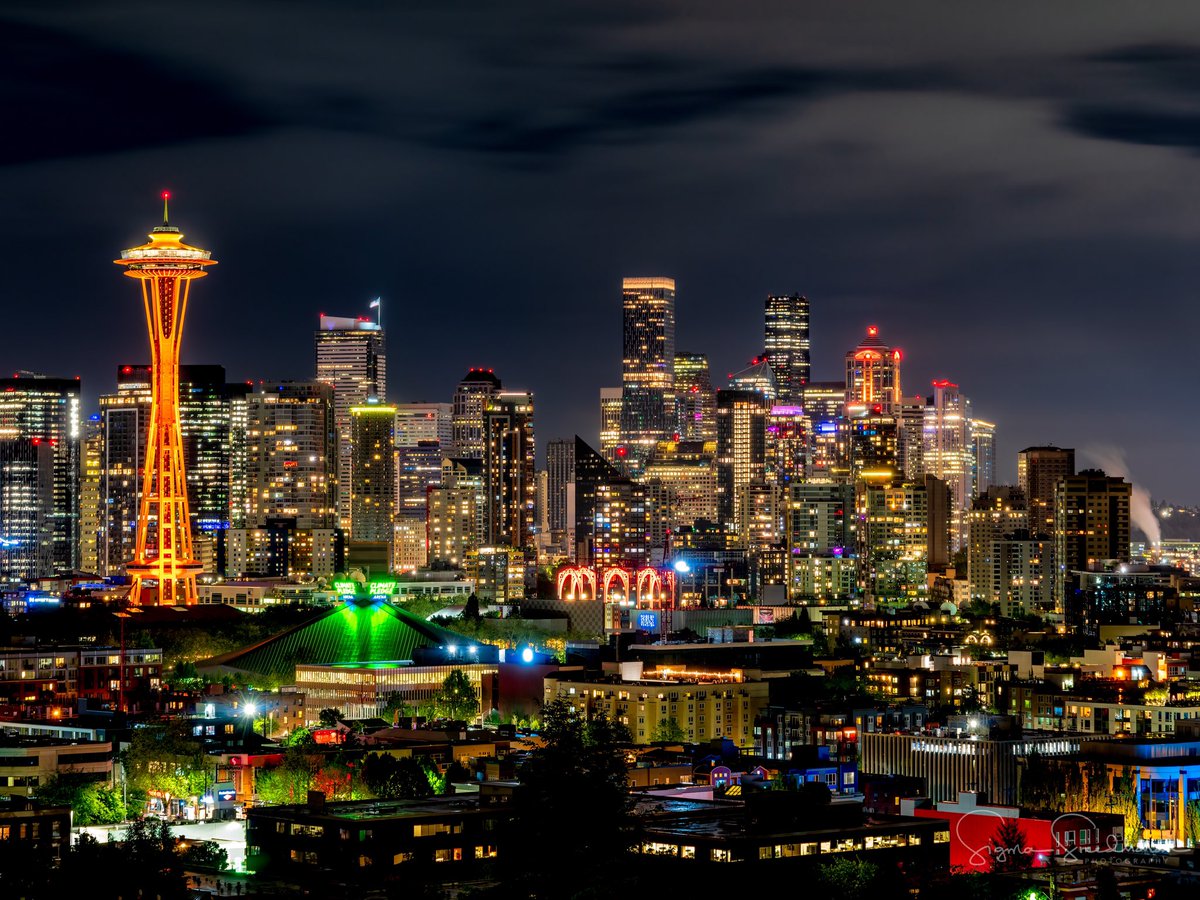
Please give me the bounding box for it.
[0,0,1200,503]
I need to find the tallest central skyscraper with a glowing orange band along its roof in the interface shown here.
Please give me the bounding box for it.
[620,277,676,473]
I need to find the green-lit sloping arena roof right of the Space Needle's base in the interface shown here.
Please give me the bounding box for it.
[198,600,466,678]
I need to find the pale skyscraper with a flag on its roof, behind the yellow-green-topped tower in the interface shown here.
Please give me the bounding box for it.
[314,314,388,528]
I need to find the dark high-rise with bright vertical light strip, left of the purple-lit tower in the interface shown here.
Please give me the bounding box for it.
[716,390,768,534]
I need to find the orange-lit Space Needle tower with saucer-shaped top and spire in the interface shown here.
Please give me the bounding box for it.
[113,204,216,606]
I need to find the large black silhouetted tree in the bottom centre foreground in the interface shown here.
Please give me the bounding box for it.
[502,698,634,898]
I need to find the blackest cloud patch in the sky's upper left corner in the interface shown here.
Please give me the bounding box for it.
[0,20,270,164]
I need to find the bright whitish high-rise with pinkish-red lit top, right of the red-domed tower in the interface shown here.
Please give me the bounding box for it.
[922,379,974,551]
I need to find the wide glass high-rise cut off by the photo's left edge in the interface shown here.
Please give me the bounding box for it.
[0,372,79,577]
